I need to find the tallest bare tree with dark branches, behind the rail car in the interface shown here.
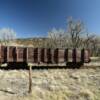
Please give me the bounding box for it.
[68,17,85,48]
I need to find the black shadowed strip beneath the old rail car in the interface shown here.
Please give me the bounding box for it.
[0,62,83,70]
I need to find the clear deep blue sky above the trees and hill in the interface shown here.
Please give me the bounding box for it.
[0,0,100,37]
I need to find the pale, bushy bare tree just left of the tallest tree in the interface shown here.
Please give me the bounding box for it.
[46,28,67,48]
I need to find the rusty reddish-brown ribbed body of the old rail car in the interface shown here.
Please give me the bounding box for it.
[0,45,90,65]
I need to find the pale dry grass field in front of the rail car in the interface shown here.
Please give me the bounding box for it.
[0,68,100,100]
